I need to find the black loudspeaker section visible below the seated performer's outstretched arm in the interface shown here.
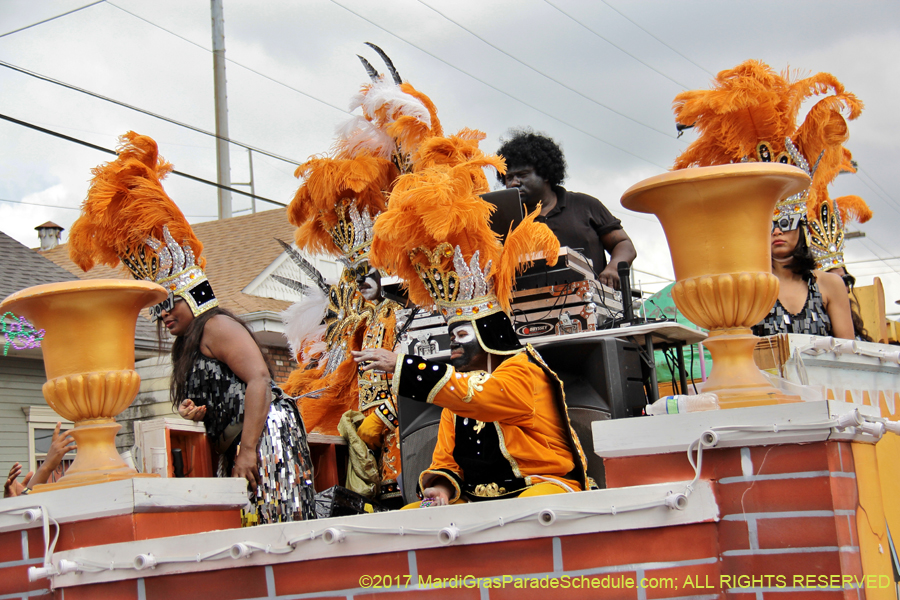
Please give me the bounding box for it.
[397,396,443,504]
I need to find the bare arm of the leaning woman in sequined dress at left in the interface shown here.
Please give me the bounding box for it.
[200,315,272,491]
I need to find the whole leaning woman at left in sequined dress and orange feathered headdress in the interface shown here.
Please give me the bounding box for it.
[69,132,315,523]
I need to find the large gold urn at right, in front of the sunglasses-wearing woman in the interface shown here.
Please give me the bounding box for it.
[622,162,810,408]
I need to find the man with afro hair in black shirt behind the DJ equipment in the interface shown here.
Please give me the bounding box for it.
[497,130,637,289]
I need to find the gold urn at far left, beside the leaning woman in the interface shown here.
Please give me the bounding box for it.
[0,279,167,492]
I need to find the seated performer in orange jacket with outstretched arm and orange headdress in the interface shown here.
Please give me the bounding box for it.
[354,130,588,505]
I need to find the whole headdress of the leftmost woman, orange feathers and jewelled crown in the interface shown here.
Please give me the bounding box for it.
[69,131,219,317]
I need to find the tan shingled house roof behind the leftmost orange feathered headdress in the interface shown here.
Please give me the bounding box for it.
[41,208,294,315]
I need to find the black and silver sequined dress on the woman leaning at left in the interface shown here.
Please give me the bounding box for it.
[185,356,316,524]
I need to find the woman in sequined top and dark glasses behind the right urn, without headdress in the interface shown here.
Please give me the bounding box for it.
[753,219,854,340]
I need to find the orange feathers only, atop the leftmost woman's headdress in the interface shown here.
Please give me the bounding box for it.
[68,131,206,271]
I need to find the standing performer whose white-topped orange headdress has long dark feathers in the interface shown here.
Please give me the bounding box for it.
[287,44,442,506]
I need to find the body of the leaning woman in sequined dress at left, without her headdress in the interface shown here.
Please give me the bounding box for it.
[160,296,315,523]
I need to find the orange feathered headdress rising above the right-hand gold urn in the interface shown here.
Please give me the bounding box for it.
[674,60,862,229]
